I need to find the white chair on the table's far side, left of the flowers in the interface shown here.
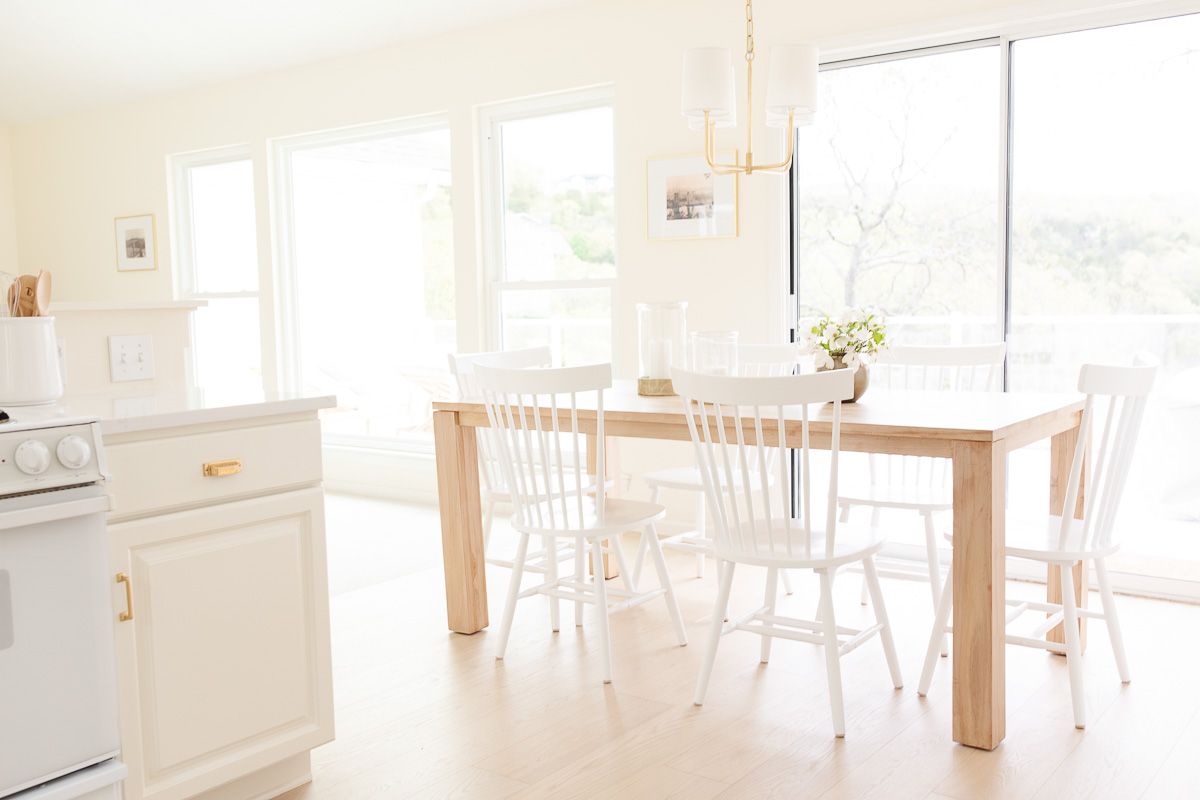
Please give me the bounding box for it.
[634,344,799,585]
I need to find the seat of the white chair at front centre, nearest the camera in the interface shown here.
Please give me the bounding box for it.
[715,521,886,570]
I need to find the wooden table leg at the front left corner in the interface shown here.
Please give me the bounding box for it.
[433,411,487,633]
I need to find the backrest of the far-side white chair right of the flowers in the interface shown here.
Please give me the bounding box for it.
[868,342,1006,487]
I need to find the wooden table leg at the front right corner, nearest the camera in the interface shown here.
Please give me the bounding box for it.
[952,441,1006,750]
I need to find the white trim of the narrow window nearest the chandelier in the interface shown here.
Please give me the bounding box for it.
[479,84,617,351]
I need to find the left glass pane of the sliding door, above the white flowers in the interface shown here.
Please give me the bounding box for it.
[796,46,1003,344]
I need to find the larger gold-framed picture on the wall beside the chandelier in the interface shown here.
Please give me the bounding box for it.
[646,154,738,239]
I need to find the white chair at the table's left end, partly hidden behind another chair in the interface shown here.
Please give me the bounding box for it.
[449,347,574,573]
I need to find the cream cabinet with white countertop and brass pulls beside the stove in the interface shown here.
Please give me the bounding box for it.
[23,392,335,800]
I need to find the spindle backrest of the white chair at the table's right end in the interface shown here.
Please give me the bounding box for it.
[1058,362,1158,549]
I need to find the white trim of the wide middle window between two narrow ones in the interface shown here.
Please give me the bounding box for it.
[266,114,450,398]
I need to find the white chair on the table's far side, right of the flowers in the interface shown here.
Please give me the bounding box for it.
[838,342,1006,655]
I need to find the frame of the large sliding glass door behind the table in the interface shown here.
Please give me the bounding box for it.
[781,10,1200,602]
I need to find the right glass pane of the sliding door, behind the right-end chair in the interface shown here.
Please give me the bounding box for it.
[1009,16,1200,594]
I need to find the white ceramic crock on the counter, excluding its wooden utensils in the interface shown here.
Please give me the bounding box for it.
[0,317,62,408]
